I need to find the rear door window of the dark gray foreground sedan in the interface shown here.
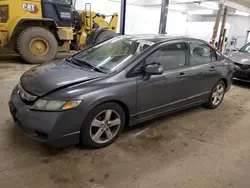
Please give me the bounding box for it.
[189,42,217,65]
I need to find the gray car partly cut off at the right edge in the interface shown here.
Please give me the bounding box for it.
[230,43,250,82]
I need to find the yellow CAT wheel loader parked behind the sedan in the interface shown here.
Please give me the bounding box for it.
[0,0,118,63]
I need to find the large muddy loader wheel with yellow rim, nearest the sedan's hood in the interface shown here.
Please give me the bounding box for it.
[16,27,58,64]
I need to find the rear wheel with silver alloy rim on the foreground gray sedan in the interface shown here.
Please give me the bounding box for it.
[205,80,226,109]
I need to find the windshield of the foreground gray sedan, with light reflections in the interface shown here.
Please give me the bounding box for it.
[72,37,154,72]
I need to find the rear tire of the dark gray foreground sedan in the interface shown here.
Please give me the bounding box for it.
[204,80,226,109]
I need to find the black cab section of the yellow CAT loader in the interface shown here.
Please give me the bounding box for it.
[41,0,81,27]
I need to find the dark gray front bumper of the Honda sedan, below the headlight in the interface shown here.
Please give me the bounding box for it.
[9,87,83,148]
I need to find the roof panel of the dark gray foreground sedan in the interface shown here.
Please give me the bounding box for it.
[122,34,200,43]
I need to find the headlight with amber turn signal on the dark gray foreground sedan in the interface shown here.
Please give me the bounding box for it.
[32,99,81,111]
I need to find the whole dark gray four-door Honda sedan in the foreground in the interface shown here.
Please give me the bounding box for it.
[9,35,234,148]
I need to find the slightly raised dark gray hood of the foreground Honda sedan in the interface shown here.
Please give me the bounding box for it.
[20,60,106,96]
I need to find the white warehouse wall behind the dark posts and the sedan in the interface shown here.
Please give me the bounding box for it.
[76,0,250,48]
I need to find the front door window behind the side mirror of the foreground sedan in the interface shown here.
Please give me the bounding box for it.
[145,42,187,70]
